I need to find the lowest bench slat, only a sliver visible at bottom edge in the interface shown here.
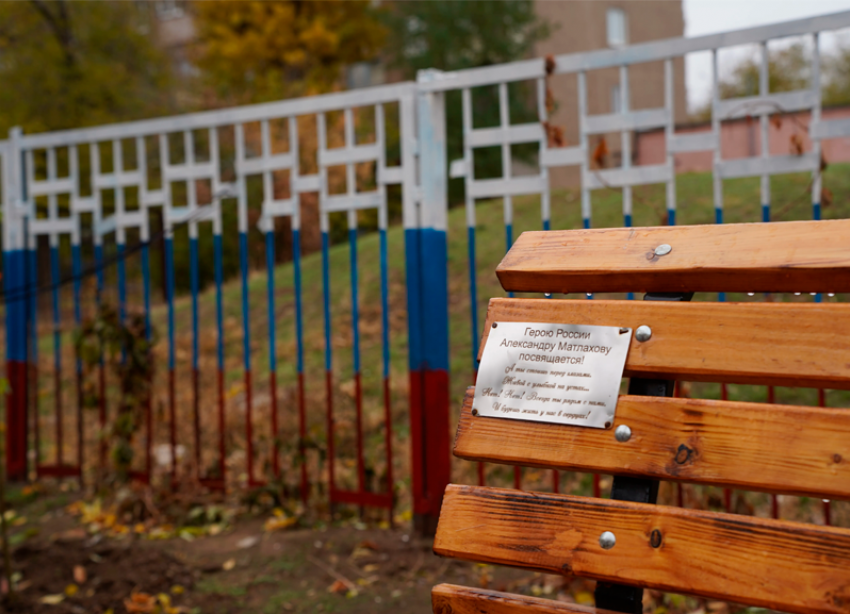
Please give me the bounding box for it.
[431,584,610,614]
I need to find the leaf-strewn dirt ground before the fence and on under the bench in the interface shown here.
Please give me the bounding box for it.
[0,486,796,614]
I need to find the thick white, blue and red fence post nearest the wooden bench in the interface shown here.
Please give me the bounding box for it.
[405,70,451,535]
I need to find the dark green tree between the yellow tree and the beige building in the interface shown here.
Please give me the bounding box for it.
[385,0,551,207]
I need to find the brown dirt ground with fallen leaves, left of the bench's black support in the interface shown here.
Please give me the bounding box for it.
[4,490,608,614]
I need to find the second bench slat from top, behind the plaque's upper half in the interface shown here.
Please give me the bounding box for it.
[479,298,850,390]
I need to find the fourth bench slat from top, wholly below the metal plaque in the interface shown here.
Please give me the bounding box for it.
[434,485,850,614]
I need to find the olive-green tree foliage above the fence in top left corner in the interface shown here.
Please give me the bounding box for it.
[0,0,169,134]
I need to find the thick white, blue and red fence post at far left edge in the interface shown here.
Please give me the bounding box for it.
[3,128,29,480]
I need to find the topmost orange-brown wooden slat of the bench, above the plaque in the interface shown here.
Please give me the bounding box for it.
[496,220,850,293]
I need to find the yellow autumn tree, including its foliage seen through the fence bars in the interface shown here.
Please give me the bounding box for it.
[189,0,386,283]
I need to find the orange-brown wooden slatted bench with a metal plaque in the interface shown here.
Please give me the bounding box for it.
[432,220,850,614]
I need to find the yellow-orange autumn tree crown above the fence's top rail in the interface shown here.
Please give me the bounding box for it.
[193,0,385,104]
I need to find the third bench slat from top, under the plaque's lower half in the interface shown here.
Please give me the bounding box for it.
[454,388,850,499]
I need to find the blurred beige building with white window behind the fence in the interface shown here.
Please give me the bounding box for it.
[535,0,687,188]
